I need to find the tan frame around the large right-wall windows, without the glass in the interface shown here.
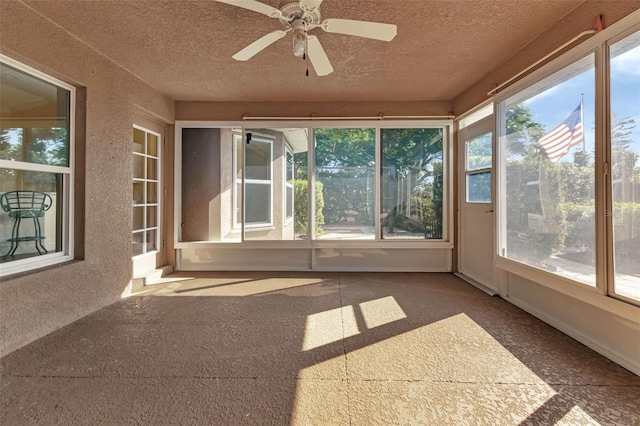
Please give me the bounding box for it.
[493,13,640,306]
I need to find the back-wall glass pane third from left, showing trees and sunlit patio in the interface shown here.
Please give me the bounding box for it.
[314,129,376,240]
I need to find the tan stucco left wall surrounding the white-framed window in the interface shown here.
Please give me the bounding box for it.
[0,1,174,355]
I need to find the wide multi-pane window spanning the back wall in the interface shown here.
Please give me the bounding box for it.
[178,122,451,247]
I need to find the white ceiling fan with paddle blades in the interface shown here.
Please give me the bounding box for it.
[216,0,397,76]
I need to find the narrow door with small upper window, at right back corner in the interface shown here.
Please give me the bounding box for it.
[458,115,498,293]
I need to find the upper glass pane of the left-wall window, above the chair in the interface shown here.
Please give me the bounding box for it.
[0,63,71,166]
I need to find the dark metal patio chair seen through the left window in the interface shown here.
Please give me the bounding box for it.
[0,190,53,259]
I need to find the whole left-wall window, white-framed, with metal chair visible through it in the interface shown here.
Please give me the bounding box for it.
[0,56,75,274]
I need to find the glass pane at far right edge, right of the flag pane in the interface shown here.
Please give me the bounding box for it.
[610,31,640,301]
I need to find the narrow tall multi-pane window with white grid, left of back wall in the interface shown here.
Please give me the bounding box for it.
[132,127,160,256]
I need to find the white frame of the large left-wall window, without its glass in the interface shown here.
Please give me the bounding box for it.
[0,54,76,276]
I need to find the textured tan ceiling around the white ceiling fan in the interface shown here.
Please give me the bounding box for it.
[24,0,584,102]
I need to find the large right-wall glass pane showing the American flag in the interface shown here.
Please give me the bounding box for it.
[500,55,595,286]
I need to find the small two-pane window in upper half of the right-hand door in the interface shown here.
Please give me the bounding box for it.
[465,132,493,204]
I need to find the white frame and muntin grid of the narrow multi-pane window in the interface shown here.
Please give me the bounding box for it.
[132,124,162,259]
